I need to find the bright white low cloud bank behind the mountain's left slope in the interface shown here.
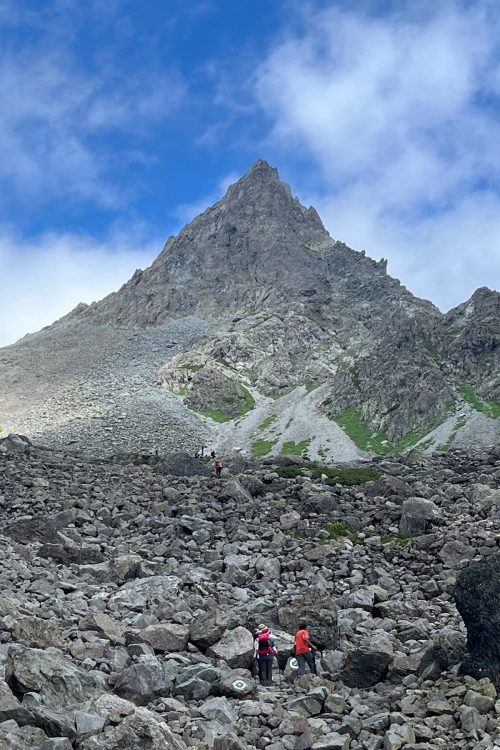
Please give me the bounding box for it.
[0,227,159,346]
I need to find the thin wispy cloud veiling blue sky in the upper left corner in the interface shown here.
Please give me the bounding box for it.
[0,6,185,212]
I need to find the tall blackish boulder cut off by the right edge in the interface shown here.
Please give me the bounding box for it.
[454,555,500,687]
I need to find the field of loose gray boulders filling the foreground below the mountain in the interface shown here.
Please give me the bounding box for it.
[0,437,500,750]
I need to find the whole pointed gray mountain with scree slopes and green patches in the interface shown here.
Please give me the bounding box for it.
[0,161,500,460]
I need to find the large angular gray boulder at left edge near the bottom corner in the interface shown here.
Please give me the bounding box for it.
[5,645,106,708]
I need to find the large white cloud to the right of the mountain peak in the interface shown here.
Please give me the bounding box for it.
[255,0,500,308]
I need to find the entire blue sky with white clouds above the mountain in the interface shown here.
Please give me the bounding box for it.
[0,0,500,345]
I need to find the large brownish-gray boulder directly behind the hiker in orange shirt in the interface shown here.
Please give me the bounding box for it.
[278,589,340,649]
